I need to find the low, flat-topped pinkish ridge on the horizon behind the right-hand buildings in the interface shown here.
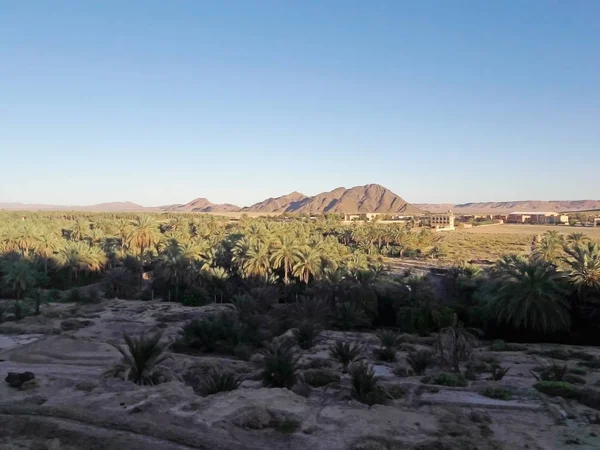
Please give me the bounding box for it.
[416,200,600,214]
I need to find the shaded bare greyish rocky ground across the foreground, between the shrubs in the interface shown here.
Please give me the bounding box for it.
[0,300,600,450]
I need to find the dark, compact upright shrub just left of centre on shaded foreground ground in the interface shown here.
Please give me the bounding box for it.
[261,344,300,389]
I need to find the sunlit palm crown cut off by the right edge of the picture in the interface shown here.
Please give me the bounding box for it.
[565,243,600,301]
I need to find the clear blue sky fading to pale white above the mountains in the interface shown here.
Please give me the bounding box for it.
[0,0,600,205]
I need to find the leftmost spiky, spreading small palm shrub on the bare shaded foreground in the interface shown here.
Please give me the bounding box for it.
[114,332,167,385]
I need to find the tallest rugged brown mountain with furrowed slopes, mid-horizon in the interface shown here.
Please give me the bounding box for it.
[246,184,421,214]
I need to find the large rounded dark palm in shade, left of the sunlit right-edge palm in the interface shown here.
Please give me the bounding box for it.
[493,261,570,333]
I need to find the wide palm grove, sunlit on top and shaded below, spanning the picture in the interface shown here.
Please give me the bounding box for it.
[0,212,600,345]
